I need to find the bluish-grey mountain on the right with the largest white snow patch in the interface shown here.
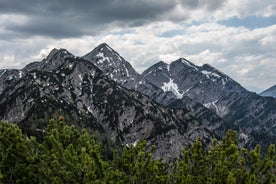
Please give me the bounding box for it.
[142,58,276,147]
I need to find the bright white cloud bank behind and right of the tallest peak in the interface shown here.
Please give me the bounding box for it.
[85,22,276,91]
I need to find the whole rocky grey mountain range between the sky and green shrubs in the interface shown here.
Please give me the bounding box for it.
[0,43,276,160]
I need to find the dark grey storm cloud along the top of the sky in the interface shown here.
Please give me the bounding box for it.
[0,0,226,38]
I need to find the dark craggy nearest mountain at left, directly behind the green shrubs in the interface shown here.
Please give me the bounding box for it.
[0,49,218,160]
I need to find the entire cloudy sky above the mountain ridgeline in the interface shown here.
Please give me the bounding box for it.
[0,0,276,92]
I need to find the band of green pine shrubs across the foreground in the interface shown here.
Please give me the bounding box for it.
[0,117,276,184]
